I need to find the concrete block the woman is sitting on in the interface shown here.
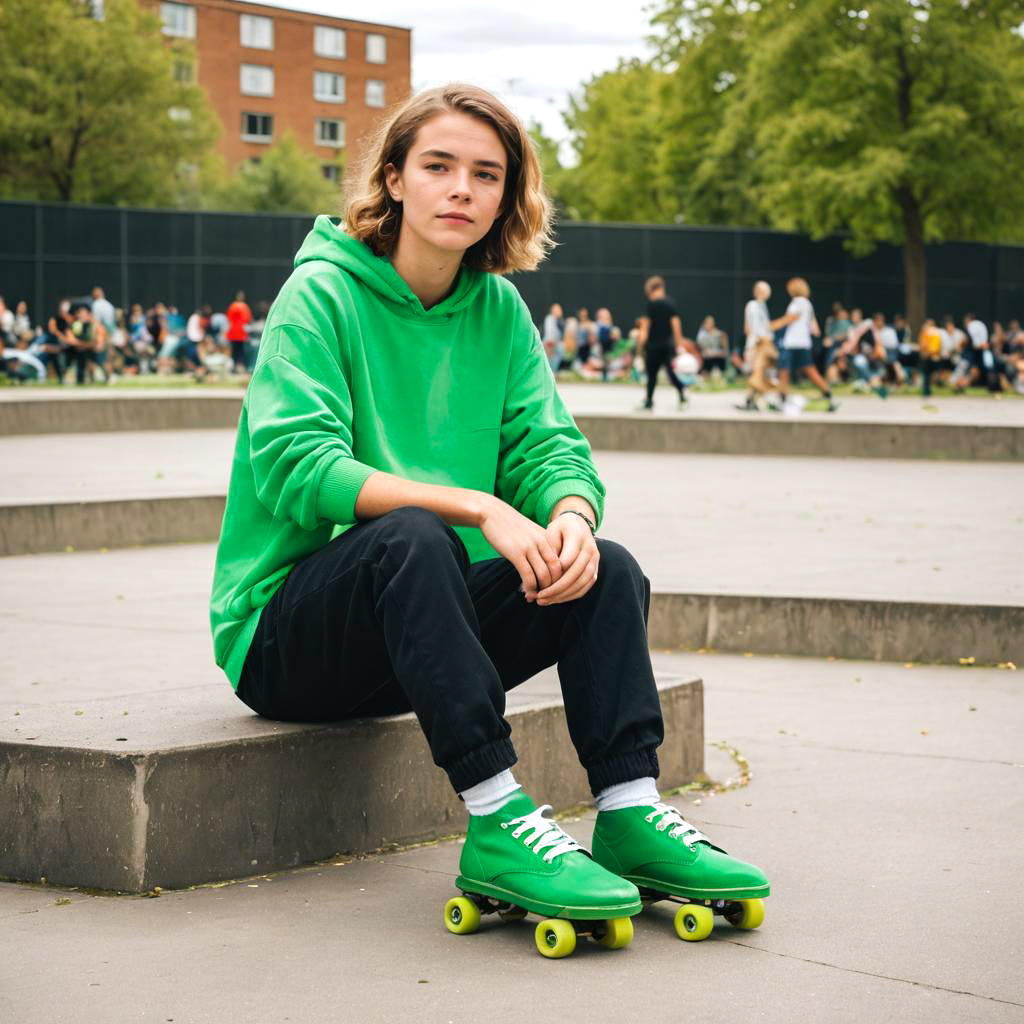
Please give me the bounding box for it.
[0,670,703,893]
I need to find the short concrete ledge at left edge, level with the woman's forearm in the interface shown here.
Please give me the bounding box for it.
[0,495,225,557]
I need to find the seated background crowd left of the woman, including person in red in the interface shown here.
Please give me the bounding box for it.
[0,286,268,384]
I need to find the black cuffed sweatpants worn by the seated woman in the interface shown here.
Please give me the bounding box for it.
[238,507,664,794]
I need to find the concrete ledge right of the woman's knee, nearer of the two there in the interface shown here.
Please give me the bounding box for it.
[648,593,1024,665]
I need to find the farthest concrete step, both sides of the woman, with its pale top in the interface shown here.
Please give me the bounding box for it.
[0,384,1024,462]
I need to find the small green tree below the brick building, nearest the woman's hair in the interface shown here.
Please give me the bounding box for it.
[212,135,344,213]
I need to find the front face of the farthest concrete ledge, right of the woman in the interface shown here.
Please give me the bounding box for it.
[575,414,1024,462]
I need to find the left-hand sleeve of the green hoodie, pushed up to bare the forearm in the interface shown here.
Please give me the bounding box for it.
[246,325,375,530]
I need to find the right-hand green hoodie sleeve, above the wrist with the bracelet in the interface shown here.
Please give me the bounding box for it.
[495,300,605,526]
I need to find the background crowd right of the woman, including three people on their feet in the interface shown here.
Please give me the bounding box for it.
[541,278,1024,412]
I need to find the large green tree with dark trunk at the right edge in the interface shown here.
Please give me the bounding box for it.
[663,0,1024,328]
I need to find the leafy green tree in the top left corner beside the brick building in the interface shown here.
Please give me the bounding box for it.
[0,0,218,206]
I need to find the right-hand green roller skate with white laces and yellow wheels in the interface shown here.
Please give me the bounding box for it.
[593,803,770,942]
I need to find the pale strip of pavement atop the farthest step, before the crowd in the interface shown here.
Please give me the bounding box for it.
[0,377,1024,426]
